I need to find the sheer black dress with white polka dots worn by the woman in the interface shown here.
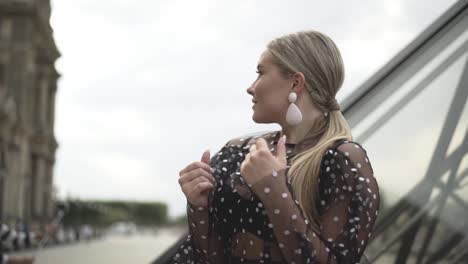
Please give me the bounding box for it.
[172,131,380,264]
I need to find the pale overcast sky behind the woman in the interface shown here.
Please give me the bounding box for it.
[51,0,455,216]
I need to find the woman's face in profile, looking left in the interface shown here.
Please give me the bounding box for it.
[247,50,293,124]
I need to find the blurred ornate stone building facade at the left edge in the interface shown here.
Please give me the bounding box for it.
[0,0,60,223]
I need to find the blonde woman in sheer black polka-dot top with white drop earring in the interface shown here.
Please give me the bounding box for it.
[172,31,380,264]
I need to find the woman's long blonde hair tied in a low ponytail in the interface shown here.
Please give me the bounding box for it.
[267,31,352,230]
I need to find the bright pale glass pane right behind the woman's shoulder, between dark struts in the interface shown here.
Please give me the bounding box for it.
[356,50,468,206]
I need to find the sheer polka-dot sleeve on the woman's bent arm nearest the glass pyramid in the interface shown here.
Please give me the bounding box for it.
[252,142,380,264]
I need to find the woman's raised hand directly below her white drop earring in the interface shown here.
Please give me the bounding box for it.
[240,136,287,186]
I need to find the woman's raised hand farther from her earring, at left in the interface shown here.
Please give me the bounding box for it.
[179,150,215,207]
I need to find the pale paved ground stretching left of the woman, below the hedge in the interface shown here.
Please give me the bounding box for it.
[11,230,181,264]
